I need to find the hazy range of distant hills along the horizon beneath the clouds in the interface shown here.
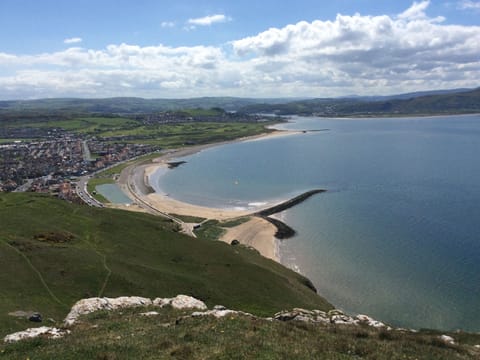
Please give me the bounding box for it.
[0,88,480,117]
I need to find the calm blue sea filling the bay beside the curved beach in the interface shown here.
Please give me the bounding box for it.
[153,115,480,331]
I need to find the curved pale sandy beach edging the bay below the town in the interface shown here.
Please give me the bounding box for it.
[118,131,299,261]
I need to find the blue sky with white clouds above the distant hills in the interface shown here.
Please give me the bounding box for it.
[0,0,480,100]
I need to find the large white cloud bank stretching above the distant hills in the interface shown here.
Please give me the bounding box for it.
[0,1,480,99]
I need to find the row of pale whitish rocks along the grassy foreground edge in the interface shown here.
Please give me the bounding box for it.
[4,295,468,344]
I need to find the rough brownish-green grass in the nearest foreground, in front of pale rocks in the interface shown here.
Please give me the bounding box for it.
[0,308,480,360]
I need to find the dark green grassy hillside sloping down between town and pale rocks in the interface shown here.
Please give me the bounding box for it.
[0,193,330,335]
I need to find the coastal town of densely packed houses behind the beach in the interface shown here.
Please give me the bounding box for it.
[0,129,159,195]
